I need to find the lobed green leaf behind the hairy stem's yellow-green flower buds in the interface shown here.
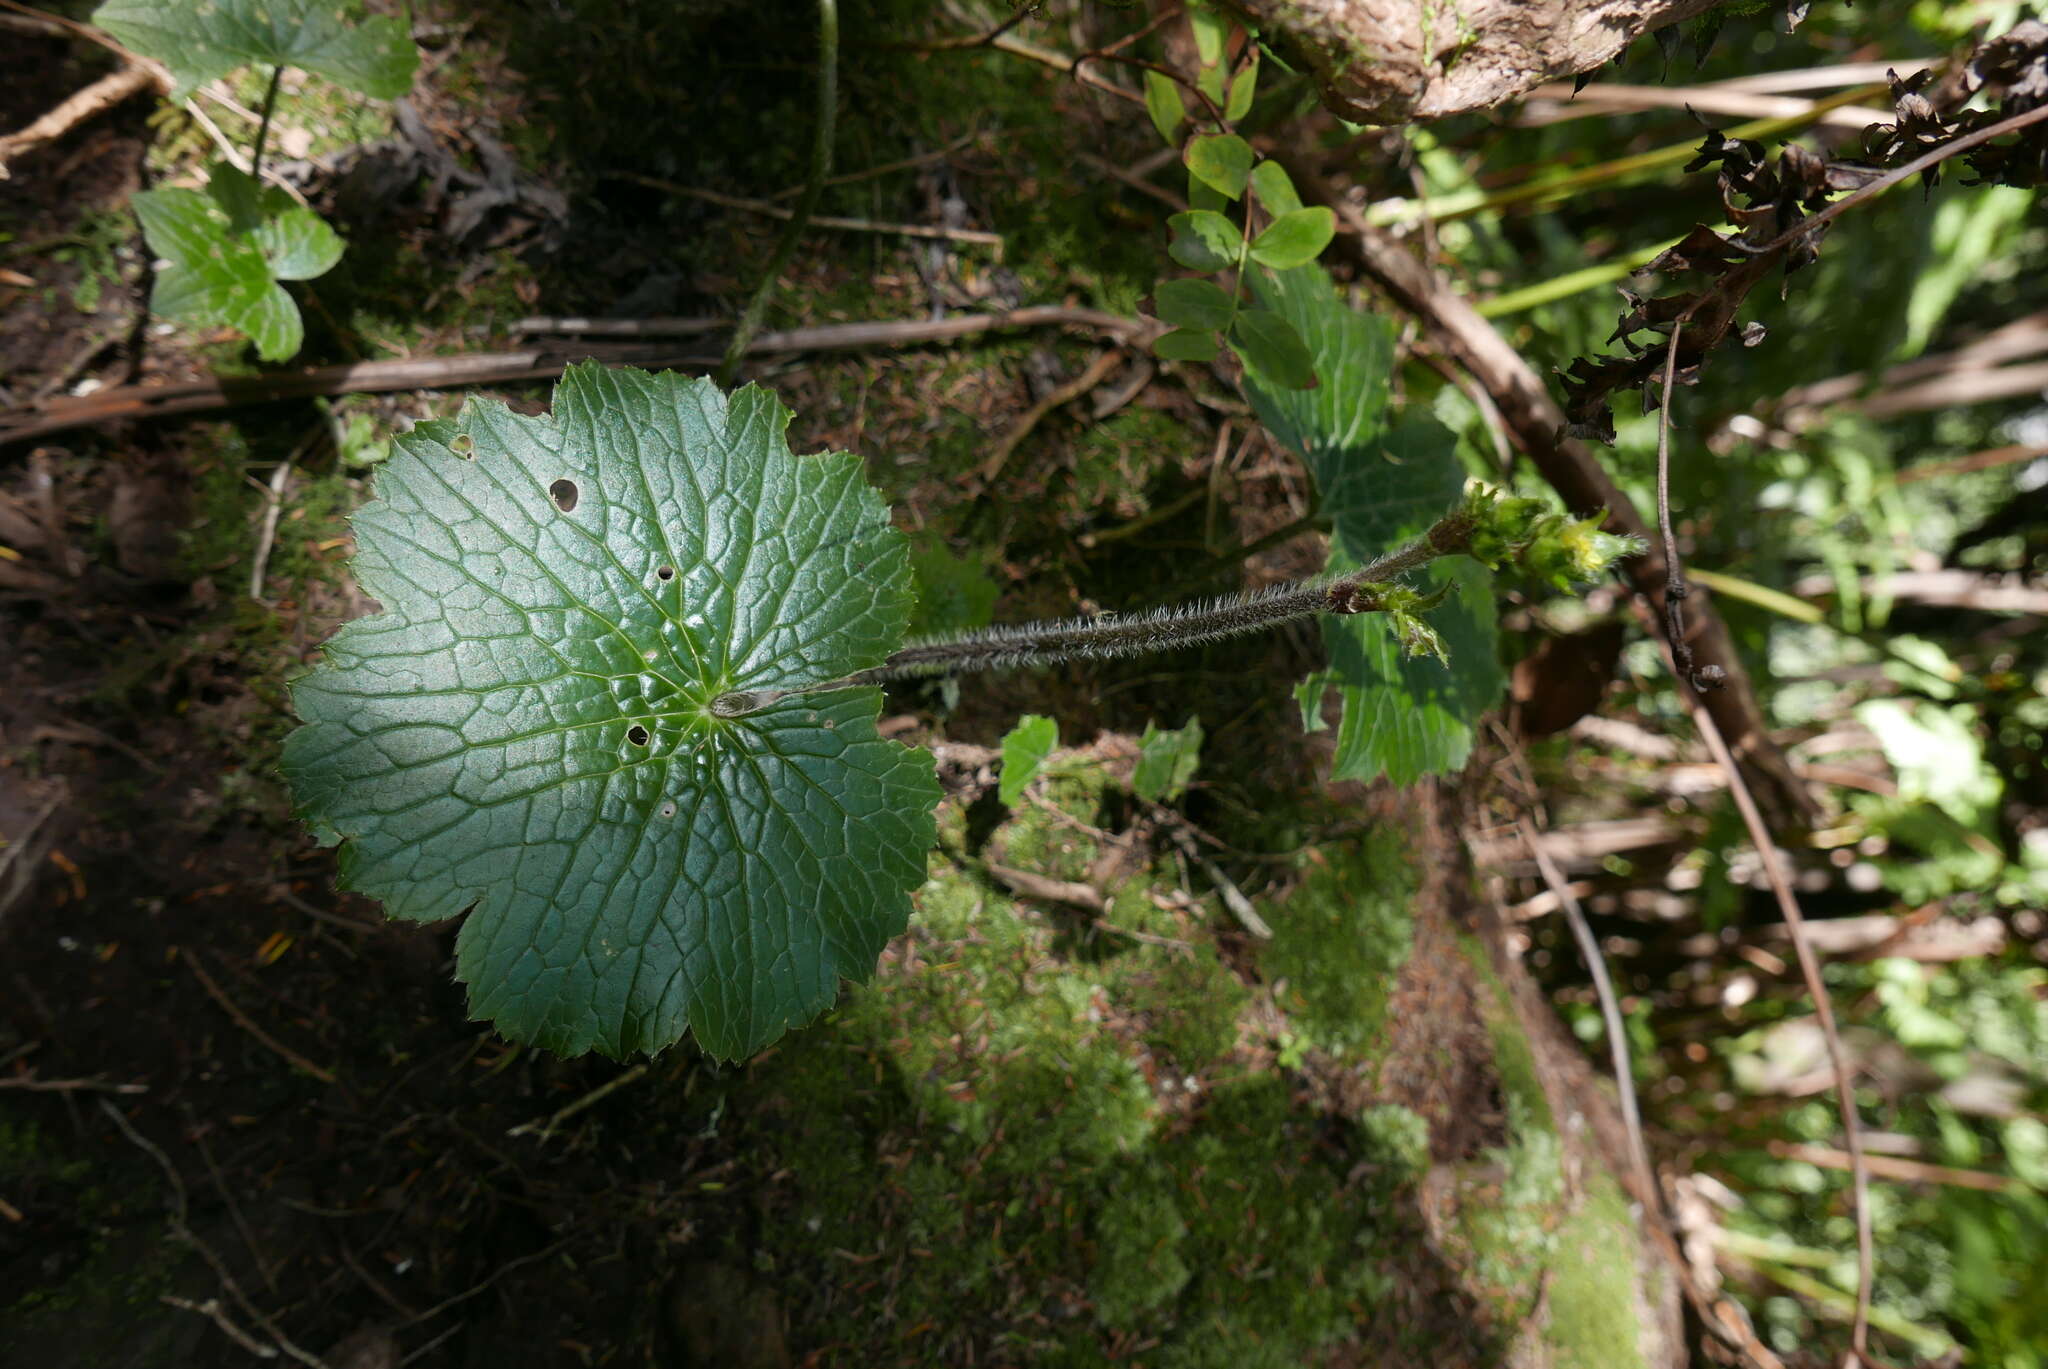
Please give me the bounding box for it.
[1245,266,1505,785]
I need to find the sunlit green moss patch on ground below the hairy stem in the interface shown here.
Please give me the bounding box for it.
[745,752,1413,1369]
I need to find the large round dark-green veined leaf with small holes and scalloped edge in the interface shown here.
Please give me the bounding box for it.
[283,363,938,1060]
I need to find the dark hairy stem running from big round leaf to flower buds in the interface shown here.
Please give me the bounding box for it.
[711,510,1475,717]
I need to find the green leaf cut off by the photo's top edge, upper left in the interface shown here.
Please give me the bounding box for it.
[92,0,420,100]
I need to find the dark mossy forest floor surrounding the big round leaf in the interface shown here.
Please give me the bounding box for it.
[0,2,1597,1369]
